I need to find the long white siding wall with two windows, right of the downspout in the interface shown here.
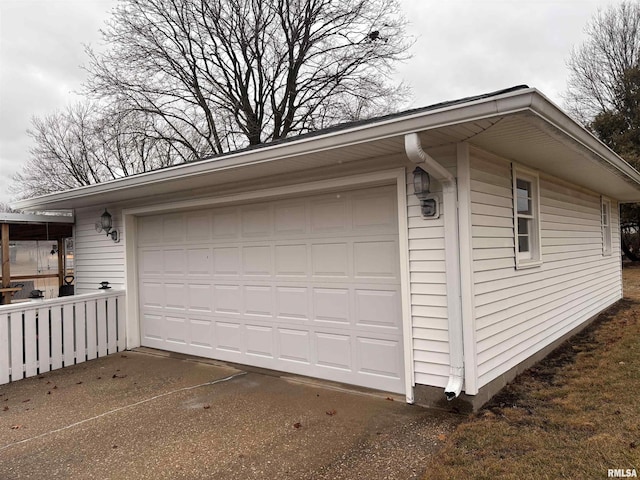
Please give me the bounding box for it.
[471,150,622,387]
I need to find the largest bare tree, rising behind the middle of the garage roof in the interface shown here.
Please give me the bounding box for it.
[87,0,409,156]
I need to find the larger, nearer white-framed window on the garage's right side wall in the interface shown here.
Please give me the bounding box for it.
[513,167,541,268]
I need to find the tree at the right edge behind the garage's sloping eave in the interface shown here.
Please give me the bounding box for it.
[566,1,640,260]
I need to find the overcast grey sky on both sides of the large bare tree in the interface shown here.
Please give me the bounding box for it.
[0,0,619,202]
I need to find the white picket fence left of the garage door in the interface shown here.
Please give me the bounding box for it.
[0,290,126,385]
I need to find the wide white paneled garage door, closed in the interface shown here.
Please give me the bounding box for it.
[138,186,404,393]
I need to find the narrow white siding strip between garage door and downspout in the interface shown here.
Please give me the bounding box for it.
[407,146,456,388]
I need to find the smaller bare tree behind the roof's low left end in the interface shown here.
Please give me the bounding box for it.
[11,102,182,197]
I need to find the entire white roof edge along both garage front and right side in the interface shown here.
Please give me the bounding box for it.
[11,86,640,210]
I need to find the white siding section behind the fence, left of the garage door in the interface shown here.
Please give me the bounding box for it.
[74,206,125,293]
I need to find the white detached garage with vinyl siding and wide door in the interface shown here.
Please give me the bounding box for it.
[14,87,640,408]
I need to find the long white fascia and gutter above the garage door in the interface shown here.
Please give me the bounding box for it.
[12,89,535,210]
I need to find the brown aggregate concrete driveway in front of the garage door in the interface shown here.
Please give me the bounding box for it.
[0,352,461,480]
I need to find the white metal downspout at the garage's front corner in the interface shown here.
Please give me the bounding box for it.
[404,133,464,400]
